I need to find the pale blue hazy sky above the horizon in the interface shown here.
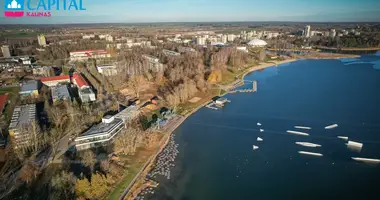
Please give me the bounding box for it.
[0,0,380,24]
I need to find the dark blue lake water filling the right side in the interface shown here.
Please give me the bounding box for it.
[148,54,380,200]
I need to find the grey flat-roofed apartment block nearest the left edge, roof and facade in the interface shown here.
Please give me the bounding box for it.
[8,104,36,148]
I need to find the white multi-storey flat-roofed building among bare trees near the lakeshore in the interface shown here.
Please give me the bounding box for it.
[75,116,124,151]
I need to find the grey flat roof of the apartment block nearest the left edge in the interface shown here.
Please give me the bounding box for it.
[9,104,36,130]
